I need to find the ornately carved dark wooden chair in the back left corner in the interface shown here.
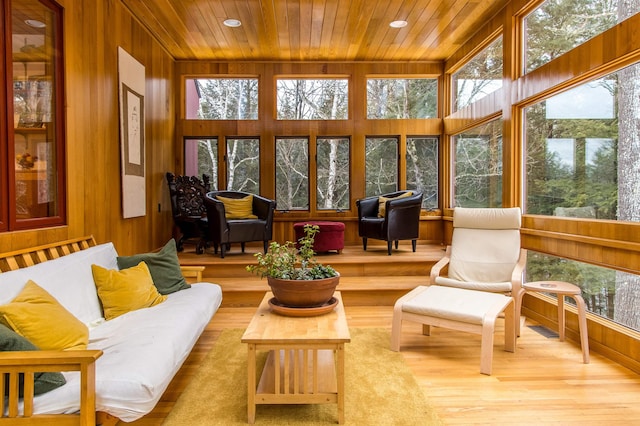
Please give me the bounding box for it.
[167,172,211,254]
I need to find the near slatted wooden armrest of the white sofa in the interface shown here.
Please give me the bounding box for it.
[0,350,102,425]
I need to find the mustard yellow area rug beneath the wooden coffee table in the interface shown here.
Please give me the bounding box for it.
[164,328,442,426]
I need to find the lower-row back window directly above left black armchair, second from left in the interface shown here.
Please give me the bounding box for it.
[226,138,260,194]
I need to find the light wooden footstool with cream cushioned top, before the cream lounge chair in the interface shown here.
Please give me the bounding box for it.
[391,285,516,375]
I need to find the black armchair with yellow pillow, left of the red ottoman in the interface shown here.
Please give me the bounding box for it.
[204,191,276,258]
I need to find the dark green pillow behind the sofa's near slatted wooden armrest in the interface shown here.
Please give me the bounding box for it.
[0,324,67,398]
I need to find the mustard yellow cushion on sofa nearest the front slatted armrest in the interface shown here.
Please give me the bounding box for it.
[0,280,89,350]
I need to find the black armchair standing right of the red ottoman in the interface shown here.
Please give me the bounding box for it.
[356,191,422,255]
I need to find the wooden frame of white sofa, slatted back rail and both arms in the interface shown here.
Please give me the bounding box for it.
[0,235,204,426]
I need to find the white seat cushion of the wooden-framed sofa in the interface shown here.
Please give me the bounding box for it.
[34,283,222,422]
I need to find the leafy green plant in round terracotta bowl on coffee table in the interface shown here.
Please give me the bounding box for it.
[246,225,340,308]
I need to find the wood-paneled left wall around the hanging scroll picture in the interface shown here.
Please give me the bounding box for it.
[0,0,175,254]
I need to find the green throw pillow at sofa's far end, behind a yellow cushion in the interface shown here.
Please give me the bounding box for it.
[117,238,190,294]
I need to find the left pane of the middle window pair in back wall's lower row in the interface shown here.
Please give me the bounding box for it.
[276,138,309,210]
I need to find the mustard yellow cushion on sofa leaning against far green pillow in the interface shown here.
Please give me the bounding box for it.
[91,262,167,320]
